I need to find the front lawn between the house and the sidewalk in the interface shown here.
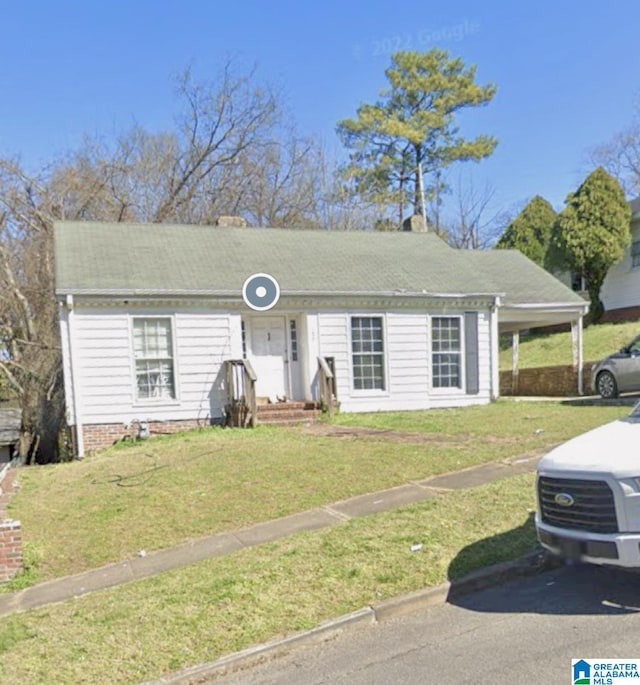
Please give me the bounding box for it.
[3,400,627,591]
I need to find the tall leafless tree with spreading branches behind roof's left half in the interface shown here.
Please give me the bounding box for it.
[56,63,277,224]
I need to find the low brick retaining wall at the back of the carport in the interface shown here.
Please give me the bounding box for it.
[500,362,593,397]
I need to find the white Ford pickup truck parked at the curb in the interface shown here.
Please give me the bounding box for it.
[536,403,640,568]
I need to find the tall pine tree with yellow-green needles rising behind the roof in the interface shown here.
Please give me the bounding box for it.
[337,48,497,223]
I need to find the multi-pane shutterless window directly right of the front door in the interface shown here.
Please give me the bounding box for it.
[351,316,385,390]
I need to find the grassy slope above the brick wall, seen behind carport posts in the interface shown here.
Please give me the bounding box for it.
[500,322,640,370]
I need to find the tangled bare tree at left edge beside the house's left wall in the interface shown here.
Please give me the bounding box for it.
[0,160,64,463]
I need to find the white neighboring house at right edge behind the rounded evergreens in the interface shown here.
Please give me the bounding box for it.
[600,197,640,321]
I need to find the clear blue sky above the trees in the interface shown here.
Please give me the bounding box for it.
[0,0,640,216]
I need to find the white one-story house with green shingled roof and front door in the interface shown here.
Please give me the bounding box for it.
[55,222,588,455]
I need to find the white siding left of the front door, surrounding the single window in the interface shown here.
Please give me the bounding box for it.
[66,307,242,425]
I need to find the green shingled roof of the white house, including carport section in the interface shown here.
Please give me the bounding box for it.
[55,222,583,304]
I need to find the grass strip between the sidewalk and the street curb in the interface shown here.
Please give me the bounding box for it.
[0,475,535,685]
